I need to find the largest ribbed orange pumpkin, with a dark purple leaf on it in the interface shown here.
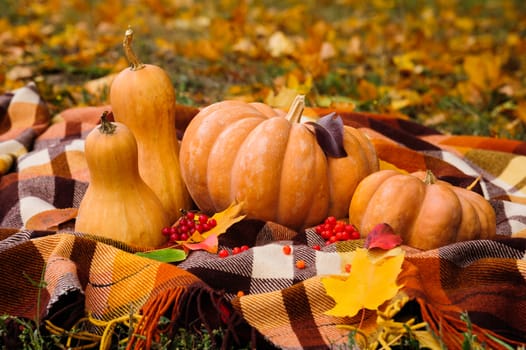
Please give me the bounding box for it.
[179,97,378,229]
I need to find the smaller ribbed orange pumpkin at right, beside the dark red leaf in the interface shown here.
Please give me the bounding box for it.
[349,170,496,250]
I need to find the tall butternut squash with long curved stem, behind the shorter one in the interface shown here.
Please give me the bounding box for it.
[110,28,191,221]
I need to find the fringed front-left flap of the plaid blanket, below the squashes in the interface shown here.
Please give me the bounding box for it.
[0,230,248,349]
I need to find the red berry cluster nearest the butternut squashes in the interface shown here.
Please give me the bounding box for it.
[162,210,217,243]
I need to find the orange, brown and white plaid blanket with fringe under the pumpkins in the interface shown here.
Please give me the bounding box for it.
[0,84,526,349]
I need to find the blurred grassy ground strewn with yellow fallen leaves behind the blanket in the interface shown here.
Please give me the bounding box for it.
[0,0,526,140]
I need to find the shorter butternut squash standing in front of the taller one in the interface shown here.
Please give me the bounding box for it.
[75,112,170,248]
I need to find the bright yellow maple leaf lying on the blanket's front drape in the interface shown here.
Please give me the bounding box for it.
[322,248,404,317]
